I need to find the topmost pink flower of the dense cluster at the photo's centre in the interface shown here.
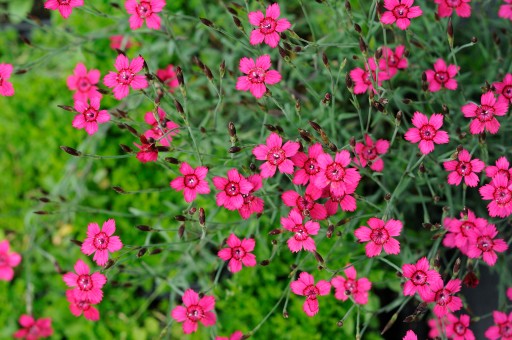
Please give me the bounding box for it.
[252,133,300,178]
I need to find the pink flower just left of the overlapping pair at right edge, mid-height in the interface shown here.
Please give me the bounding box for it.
[443,149,485,187]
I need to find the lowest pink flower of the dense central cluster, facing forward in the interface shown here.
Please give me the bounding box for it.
[281,210,320,253]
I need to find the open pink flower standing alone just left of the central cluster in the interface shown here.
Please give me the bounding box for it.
[170,162,210,203]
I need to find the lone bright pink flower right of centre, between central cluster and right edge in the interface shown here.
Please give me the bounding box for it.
[404,111,450,155]
